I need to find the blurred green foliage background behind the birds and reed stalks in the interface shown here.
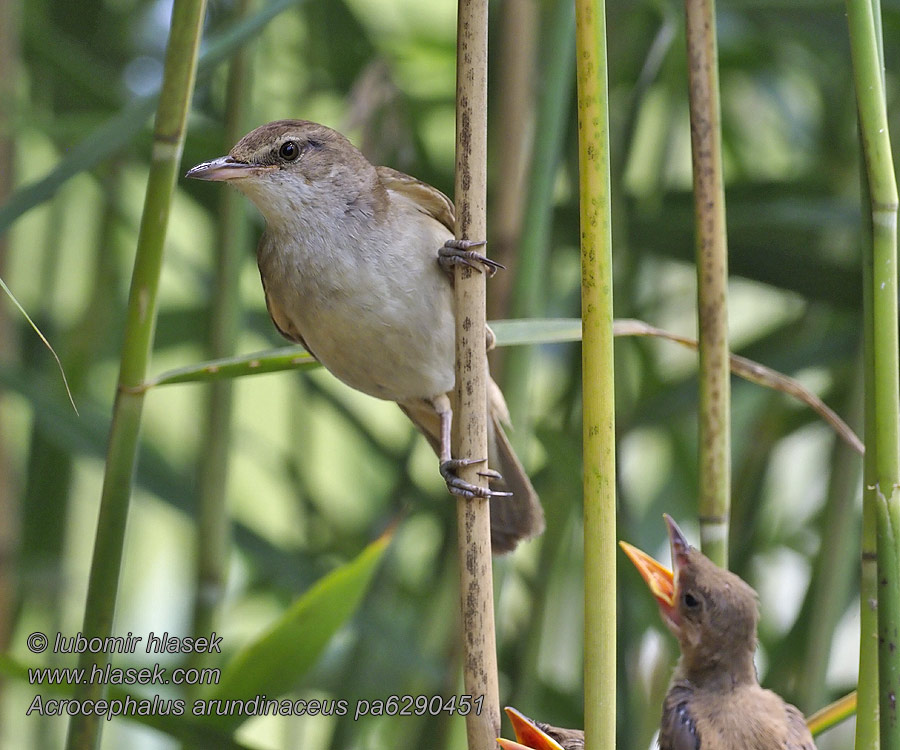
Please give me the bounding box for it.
[0,0,888,750]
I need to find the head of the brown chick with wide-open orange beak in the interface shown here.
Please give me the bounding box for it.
[620,516,759,679]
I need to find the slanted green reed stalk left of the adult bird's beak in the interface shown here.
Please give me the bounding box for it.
[66,0,206,750]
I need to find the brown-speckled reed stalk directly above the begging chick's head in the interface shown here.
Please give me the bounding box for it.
[685,0,731,567]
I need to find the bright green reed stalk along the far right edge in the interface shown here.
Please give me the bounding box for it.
[847,0,900,750]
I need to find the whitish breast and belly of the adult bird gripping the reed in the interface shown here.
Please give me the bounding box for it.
[259,184,454,401]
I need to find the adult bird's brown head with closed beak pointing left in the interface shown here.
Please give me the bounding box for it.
[186,120,375,227]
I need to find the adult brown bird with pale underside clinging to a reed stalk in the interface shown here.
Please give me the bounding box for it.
[187,120,544,552]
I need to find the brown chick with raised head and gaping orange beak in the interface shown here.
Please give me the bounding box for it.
[620,516,815,750]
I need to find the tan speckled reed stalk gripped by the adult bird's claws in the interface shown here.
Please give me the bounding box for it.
[453,0,500,750]
